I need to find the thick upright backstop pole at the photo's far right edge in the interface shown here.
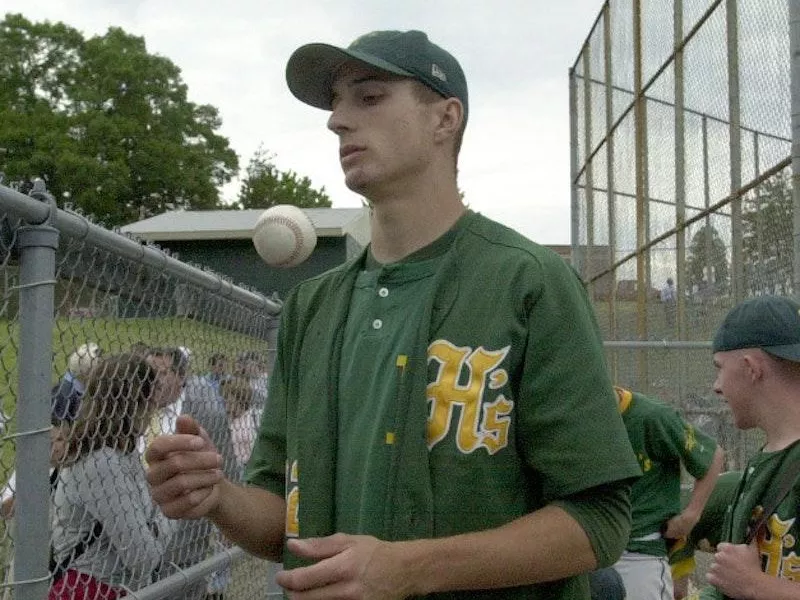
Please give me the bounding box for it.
[789,0,800,297]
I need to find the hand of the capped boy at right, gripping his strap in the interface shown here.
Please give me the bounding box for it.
[706,540,764,599]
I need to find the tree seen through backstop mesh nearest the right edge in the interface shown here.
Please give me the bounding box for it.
[742,171,794,294]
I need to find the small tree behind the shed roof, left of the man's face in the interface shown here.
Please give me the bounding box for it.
[237,146,331,208]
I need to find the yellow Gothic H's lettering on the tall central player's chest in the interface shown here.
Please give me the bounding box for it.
[427,340,514,454]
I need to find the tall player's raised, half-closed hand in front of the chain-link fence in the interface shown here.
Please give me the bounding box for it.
[145,415,223,519]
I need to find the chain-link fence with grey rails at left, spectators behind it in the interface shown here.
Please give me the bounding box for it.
[0,180,280,600]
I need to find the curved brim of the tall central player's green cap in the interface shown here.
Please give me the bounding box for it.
[286,44,414,110]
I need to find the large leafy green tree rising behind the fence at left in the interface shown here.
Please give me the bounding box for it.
[0,14,238,226]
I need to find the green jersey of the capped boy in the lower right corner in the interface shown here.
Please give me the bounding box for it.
[700,442,800,600]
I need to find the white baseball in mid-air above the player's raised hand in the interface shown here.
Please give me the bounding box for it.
[253,204,317,268]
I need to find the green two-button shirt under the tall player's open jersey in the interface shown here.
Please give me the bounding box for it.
[336,237,446,537]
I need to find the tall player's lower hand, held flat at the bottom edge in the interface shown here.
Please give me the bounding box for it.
[276,533,412,600]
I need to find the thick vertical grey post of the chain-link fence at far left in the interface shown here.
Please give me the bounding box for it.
[14,192,58,600]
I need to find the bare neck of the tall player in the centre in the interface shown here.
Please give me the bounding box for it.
[370,178,466,264]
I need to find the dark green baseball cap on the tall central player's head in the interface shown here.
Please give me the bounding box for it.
[286,31,467,122]
